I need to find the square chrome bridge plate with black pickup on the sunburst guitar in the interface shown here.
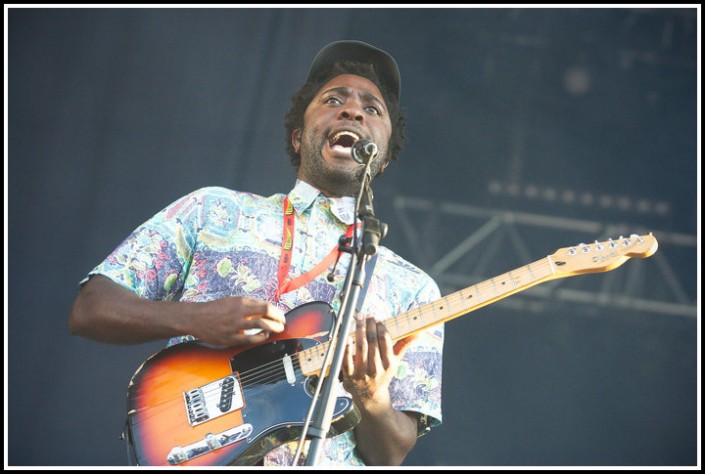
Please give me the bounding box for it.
[184,374,245,426]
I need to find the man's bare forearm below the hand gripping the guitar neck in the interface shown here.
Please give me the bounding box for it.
[355,399,418,466]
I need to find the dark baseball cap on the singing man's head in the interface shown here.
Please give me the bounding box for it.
[307,40,401,101]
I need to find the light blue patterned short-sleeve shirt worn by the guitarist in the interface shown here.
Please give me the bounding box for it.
[82,180,443,465]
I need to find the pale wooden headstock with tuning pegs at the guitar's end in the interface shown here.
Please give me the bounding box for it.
[549,234,658,276]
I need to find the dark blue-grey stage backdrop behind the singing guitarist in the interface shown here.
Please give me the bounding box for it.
[5,8,700,466]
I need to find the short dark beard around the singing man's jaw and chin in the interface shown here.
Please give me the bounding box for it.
[298,131,383,196]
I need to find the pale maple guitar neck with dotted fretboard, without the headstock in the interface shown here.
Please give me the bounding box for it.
[298,256,569,375]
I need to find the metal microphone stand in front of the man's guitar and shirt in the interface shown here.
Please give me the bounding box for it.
[294,159,387,466]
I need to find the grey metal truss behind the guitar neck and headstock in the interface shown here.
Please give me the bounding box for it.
[393,197,699,318]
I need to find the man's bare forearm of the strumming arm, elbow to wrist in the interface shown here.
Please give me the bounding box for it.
[69,275,192,344]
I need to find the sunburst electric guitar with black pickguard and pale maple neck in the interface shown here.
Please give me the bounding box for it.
[127,234,658,466]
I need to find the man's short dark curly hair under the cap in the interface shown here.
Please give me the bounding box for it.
[284,61,406,168]
